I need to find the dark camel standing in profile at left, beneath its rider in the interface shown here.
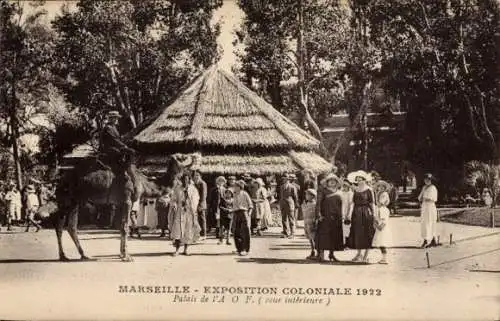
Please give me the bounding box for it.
[55,155,196,262]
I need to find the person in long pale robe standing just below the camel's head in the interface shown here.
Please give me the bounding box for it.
[168,173,201,256]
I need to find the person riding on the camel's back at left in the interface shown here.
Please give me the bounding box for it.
[99,111,136,199]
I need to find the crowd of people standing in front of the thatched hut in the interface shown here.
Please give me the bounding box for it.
[147,165,414,264]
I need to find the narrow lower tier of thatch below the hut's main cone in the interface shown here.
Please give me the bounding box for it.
[137,151,332,176]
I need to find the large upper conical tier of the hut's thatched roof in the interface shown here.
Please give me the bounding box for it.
[132,66,319,151]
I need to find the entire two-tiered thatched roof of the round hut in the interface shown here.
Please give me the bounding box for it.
[128,66,332,176]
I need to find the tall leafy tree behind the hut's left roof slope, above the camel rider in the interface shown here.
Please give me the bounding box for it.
[53,0,222,129]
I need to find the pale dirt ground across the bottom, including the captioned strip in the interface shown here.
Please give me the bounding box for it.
[0,217,500,320]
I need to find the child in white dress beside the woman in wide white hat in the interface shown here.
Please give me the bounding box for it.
[372,182,391,264]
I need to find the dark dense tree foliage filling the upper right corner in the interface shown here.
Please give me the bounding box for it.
[369,0,500,190]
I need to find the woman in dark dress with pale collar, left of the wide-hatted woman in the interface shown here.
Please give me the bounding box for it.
[316,174,344,261]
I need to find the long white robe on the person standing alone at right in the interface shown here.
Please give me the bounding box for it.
[418,185,438,242]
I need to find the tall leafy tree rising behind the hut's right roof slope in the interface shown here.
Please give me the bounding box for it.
[238,0,349,154]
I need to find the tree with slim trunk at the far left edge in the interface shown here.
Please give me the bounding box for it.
[0,0,53,188]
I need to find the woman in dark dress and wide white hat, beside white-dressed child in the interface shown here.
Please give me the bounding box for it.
[348,171,375,263]
